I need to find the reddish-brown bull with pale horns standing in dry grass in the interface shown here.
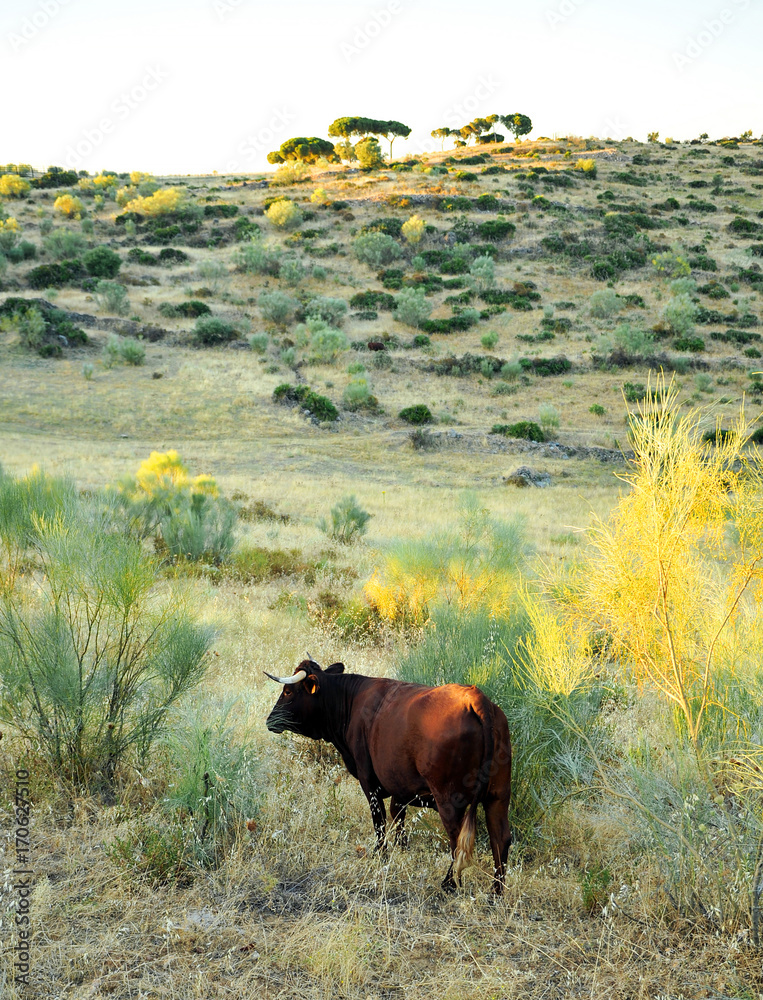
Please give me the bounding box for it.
[267,659,511,893]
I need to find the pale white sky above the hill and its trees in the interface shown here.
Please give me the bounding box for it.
[0,0,763,175]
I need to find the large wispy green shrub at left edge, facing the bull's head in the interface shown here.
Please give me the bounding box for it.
[0,473,212,795]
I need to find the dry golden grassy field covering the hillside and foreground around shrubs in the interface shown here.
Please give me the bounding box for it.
[0,139,763,1000]
